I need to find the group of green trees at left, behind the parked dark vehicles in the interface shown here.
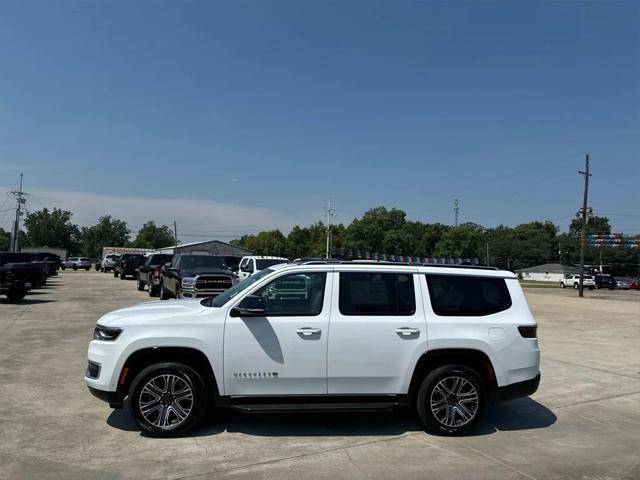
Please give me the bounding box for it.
[0,208,176,258]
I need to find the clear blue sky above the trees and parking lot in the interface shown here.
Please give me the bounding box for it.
[0,0,640,238]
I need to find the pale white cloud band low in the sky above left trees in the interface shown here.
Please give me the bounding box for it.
[0,187,310,242]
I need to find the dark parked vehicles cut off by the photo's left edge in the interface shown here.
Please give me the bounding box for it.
[0,252,62,302]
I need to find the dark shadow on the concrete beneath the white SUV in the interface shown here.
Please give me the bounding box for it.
[107,398,556,437]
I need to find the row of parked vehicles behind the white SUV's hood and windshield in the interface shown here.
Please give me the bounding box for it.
[96,253,290,300]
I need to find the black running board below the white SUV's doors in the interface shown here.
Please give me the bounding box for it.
[229,402,398,413]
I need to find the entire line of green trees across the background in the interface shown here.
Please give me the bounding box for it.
[0,207,640,276]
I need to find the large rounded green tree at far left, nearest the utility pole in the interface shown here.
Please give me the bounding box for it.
[24,208,80,253]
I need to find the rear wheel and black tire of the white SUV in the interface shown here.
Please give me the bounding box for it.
[416,365,487,436]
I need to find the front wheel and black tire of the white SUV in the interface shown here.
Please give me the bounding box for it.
[128,362,207,437]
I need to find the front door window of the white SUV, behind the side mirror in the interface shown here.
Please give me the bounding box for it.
[239,272,327,316]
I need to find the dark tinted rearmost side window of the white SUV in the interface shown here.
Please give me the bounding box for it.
[427,274,511,317]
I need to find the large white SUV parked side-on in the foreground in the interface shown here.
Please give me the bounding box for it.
[85,262,540,436]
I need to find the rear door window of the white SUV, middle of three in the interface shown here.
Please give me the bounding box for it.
[339,272,416,315]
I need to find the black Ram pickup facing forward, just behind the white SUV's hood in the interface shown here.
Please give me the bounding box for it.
[160,255,238,300]
